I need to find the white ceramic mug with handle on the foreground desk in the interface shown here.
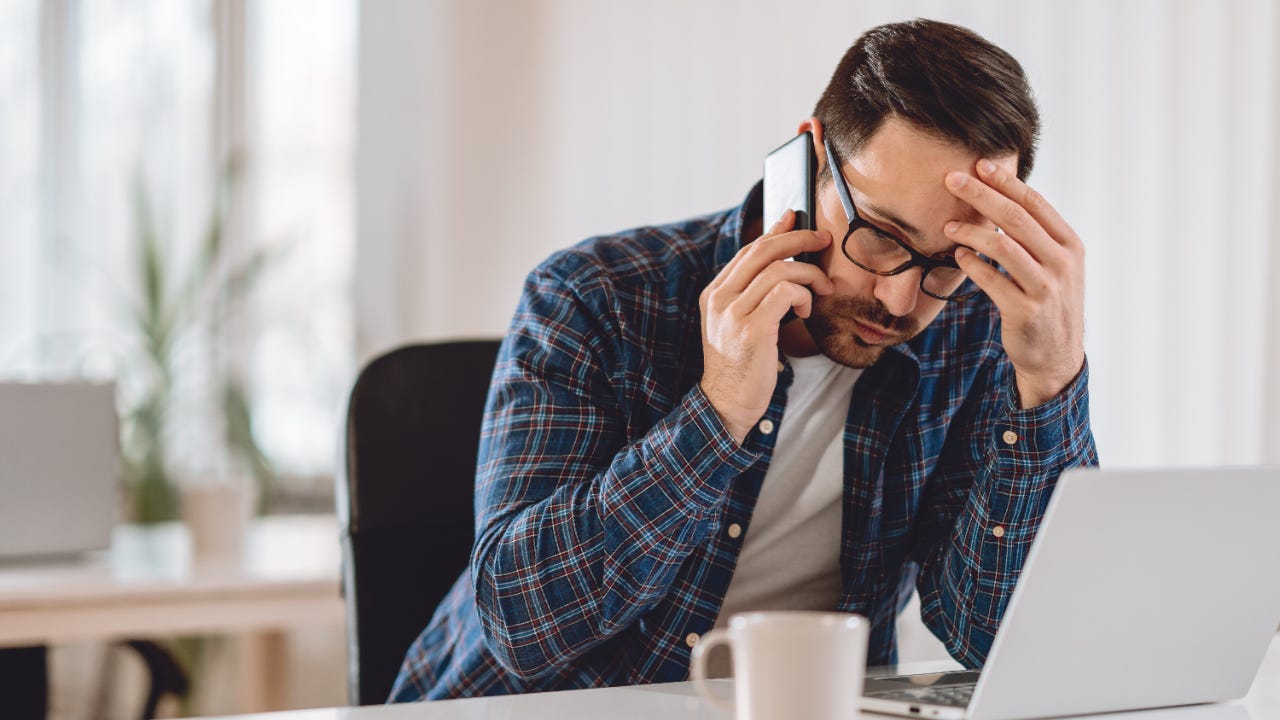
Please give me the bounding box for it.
[692,610,868,720]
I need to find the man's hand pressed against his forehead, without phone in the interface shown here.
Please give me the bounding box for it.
[945,160,1084,407]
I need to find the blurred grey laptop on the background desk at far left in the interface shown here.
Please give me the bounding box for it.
[0,383,120,559]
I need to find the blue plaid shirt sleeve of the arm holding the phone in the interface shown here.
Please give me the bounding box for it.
[471,258,758,680]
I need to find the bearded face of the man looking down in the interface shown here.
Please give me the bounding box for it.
[805,118,1018,368]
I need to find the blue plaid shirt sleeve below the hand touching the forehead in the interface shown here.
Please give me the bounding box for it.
[918,354,1098,667]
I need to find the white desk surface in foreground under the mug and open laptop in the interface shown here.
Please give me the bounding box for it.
[194,635,1280,720]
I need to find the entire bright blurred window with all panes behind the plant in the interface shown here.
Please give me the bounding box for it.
[0,0,356,509]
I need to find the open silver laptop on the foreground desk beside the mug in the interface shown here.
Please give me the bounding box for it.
[863,468,1280,720]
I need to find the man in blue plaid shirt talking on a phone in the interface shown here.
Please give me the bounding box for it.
[392,20,1097,700]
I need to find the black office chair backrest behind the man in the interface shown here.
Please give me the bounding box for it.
[337,340,498,705]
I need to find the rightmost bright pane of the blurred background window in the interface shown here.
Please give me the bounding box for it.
[248,0,356,488]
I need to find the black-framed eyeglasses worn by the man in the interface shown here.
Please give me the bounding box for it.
[823,138,996,301]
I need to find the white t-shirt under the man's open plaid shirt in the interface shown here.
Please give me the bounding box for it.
[716,354,861,625]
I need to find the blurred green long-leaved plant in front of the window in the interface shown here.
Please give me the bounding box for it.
[122,163,274,530]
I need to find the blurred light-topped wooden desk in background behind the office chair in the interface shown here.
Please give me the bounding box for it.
[0,515,343,708]
